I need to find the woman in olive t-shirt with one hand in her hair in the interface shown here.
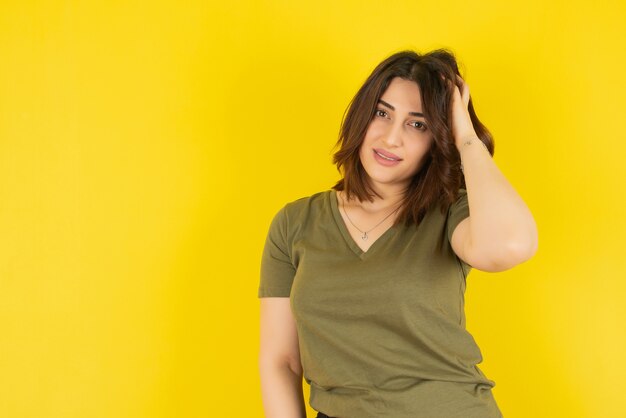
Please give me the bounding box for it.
[259,50,537,418]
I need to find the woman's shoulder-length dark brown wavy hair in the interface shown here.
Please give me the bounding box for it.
[333,49,494,229]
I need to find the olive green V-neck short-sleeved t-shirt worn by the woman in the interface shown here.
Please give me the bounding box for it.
[258,189,502,418]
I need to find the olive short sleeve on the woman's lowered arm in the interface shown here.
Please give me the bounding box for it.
[258,207,296,298]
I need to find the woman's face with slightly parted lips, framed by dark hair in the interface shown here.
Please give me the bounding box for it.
[359,77,433,190]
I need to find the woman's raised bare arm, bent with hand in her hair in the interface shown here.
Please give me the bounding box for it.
[451,76,538,272]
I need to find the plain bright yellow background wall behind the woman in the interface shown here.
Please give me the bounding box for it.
[0,0,626,418]
